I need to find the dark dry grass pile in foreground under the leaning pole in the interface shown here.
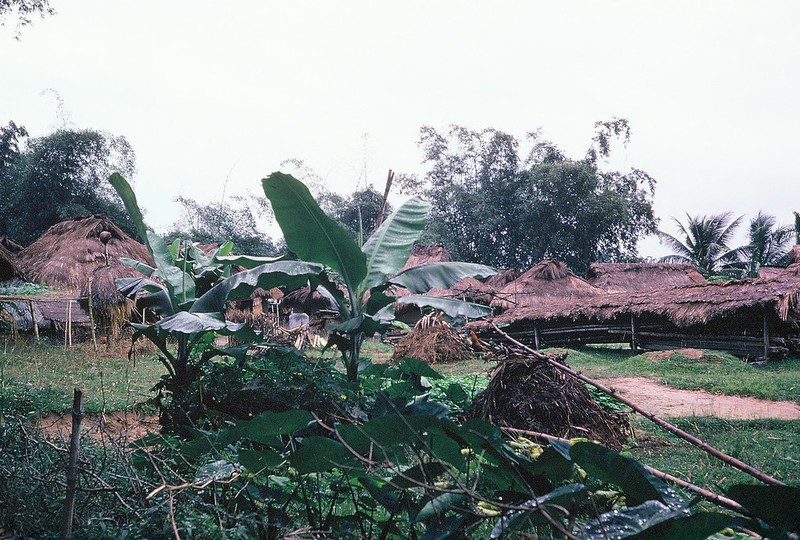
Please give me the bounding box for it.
[469,353,630,450]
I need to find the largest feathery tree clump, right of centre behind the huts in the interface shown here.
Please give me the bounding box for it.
[400,123,656,272]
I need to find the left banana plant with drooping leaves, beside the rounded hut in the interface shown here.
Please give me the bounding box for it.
[109,173,325,398]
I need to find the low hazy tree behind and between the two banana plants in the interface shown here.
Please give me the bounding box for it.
[166,195,278,256]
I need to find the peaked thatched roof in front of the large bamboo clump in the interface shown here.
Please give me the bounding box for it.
[491,259,603,310]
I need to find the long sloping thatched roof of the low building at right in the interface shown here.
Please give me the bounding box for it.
[494,265,800,327]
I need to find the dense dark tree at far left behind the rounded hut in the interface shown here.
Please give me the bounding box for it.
[0,129,136,244]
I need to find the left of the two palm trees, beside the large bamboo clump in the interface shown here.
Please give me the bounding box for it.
[656,212,744,276]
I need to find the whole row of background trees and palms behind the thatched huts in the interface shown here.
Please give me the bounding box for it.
[0,118,800,277]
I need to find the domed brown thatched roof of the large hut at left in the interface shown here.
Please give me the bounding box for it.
[17,215,153,293]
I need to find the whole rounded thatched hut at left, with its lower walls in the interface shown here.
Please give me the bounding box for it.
[17,215,153,333]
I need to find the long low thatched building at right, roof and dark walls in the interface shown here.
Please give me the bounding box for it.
[478,264,800,357]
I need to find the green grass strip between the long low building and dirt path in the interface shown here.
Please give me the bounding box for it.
[567,347,800,403]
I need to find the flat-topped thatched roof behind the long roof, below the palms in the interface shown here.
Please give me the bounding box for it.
[588,263,705,291]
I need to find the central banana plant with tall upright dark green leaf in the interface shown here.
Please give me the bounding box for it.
[262,172,497,382]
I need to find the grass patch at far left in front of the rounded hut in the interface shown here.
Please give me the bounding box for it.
[0,338,165,414]
